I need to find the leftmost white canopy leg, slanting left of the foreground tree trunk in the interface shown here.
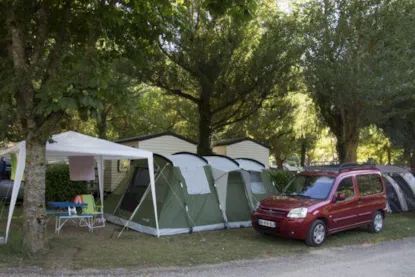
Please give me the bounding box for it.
[4,141,26,243]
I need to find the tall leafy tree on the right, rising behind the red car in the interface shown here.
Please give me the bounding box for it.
[303,0,413,162]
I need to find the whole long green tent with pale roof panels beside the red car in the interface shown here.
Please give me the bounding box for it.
[104,152,276,236]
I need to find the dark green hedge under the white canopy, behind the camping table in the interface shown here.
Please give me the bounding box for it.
[46,164,88,201]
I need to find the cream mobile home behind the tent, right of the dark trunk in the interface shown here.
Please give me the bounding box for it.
[213,138,269,168]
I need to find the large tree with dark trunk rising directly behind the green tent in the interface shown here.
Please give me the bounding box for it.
[139,0,298,155]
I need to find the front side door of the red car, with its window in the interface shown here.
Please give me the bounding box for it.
[329,176,358,232]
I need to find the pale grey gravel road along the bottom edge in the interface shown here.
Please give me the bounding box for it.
[0,238,415,277]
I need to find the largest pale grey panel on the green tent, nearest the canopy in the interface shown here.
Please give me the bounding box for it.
[167,153,210,194]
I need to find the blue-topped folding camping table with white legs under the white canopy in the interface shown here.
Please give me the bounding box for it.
[48,201,93,234]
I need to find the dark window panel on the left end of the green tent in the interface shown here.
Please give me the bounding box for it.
[120,167,150,212]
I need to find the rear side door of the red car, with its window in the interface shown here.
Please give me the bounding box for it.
[356,173,386,224]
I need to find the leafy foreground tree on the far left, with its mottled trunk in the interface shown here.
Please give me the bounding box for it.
[0,0,165,252]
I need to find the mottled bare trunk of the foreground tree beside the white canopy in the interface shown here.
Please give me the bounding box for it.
[23,136,46,252]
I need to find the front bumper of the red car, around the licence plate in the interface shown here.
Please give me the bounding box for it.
[251,213,310,240]
